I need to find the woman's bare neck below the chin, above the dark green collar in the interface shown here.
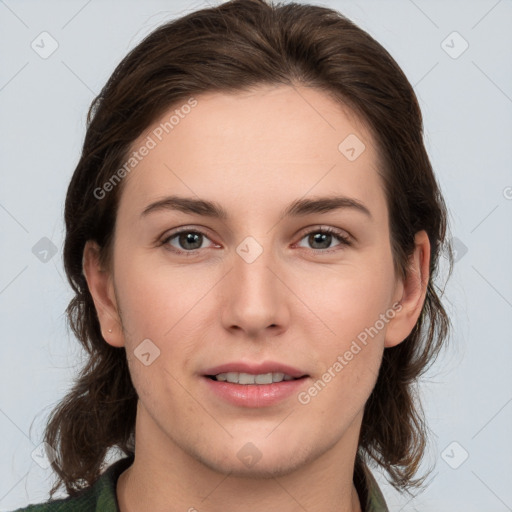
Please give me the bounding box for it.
[117,408,361,512]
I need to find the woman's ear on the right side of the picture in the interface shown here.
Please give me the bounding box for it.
[384,231,430,347]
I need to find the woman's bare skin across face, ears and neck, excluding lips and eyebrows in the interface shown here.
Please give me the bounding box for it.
[84,86,430,512]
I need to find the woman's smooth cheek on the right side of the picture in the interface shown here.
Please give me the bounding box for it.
[290,258,394,404]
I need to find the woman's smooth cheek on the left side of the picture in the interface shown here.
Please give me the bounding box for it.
[116,258,213,396]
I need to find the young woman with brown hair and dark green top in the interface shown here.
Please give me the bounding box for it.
[14,0,449,512]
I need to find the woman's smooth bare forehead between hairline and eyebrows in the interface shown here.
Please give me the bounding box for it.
[121,86,385,220]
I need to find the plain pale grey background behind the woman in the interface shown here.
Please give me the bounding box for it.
[0,0,512,512]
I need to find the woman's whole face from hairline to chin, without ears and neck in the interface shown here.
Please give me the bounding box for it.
[92,86,412,475]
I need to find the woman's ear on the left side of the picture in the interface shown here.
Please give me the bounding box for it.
[82,240,124,347]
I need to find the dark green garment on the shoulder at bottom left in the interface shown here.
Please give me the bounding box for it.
[13,456,133,512]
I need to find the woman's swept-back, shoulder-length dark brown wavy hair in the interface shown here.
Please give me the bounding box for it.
[45,0,452,496]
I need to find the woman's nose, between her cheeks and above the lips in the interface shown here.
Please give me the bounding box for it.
[221,240,290,339]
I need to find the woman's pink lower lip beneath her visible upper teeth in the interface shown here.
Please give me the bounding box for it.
[203,377,306,407]
